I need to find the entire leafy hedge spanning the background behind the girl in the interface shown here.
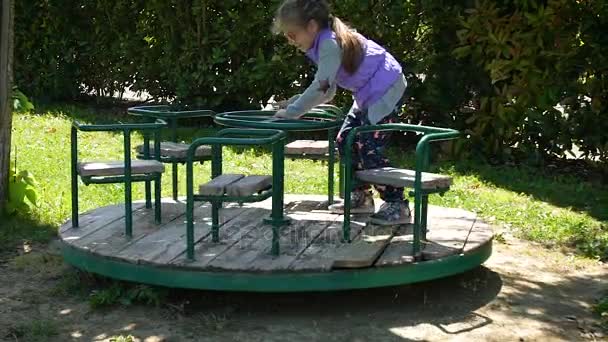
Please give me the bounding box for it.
[15,0,608,161]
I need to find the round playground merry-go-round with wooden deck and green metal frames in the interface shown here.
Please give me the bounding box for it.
[59,108,493,292]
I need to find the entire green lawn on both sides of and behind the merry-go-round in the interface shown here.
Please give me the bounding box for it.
[0,106,608,259]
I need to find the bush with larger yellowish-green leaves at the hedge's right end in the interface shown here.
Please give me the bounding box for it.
[454,0,608,161]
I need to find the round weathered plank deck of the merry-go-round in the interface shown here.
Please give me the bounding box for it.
[60,195,493,272]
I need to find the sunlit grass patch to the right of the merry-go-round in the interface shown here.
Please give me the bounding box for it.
[390,154,608,259]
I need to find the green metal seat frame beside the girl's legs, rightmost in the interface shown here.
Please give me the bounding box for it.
[341,124,460,258]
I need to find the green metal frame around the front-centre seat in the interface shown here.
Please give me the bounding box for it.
[186,128,288,260]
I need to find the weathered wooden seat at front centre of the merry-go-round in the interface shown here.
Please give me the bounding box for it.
[199,174,272,197]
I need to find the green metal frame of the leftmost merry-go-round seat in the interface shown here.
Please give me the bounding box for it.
[70,119,167,237]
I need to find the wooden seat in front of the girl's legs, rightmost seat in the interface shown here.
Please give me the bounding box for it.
[355,167,452,190]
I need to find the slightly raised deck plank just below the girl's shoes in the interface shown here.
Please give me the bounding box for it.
[332,225,395,268]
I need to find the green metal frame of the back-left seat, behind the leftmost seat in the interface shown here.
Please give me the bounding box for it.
[127,105,216,200]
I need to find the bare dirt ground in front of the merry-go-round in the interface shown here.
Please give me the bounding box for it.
[0,231,608,341]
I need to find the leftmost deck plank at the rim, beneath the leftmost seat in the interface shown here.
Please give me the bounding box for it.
[59,203,145,239]
